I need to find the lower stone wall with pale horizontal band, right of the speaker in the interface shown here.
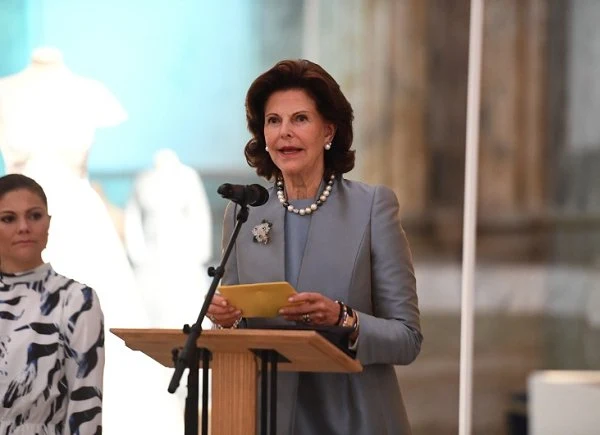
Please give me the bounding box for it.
[397,261,600,435]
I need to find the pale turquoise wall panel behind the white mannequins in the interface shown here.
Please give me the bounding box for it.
[0,0,259,176]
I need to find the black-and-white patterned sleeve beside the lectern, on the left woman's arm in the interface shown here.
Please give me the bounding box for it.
[63,285,104,435]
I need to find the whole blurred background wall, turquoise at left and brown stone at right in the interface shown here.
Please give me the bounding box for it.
[0,0,600,434]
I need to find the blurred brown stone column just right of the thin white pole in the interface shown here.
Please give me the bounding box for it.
[479,0,546,213]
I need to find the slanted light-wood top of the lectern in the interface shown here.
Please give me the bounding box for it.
[110,328,362,373]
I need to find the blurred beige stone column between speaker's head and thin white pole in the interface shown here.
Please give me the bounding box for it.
[357,0,429,216]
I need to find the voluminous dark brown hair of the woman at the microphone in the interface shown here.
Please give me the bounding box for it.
[244,59,355,180]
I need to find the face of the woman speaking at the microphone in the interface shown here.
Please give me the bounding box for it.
[264,89,335,181]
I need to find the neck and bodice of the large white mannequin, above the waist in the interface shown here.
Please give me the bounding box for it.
[0,48,127,177]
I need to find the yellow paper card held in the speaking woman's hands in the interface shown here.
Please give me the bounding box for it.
[219,281,296,317]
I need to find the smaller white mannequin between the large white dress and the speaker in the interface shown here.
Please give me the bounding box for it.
[125,149,212,328]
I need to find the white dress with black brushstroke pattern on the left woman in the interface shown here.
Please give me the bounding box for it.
[0,263,104,435]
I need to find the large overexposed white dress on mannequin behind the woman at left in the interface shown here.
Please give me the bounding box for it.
[0,48,183,434]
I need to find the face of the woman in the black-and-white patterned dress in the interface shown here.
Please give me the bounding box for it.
[0,189,50,273]
